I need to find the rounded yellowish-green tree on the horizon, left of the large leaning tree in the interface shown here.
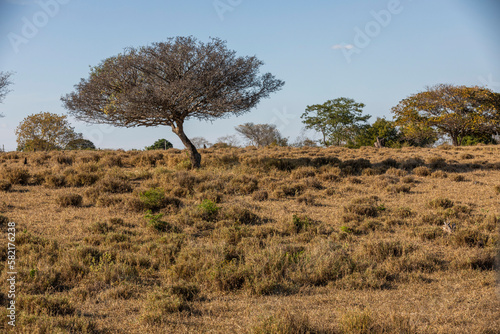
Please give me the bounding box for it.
[16,112,82,151]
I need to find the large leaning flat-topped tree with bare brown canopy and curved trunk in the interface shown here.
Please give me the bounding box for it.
[61,37,284,168]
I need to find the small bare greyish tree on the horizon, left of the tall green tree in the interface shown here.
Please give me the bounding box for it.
[235,123,287,147]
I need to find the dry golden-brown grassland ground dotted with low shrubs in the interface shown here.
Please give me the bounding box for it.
[0,145,500,333]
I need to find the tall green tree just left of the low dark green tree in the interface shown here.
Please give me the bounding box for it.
[300,97,371,146]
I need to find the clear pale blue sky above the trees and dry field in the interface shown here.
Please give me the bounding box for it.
[0,0,500,150]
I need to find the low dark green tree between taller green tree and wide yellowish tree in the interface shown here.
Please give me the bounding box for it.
[351,117,401,147]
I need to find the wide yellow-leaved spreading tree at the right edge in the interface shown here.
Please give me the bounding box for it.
[392,84,500,146]
